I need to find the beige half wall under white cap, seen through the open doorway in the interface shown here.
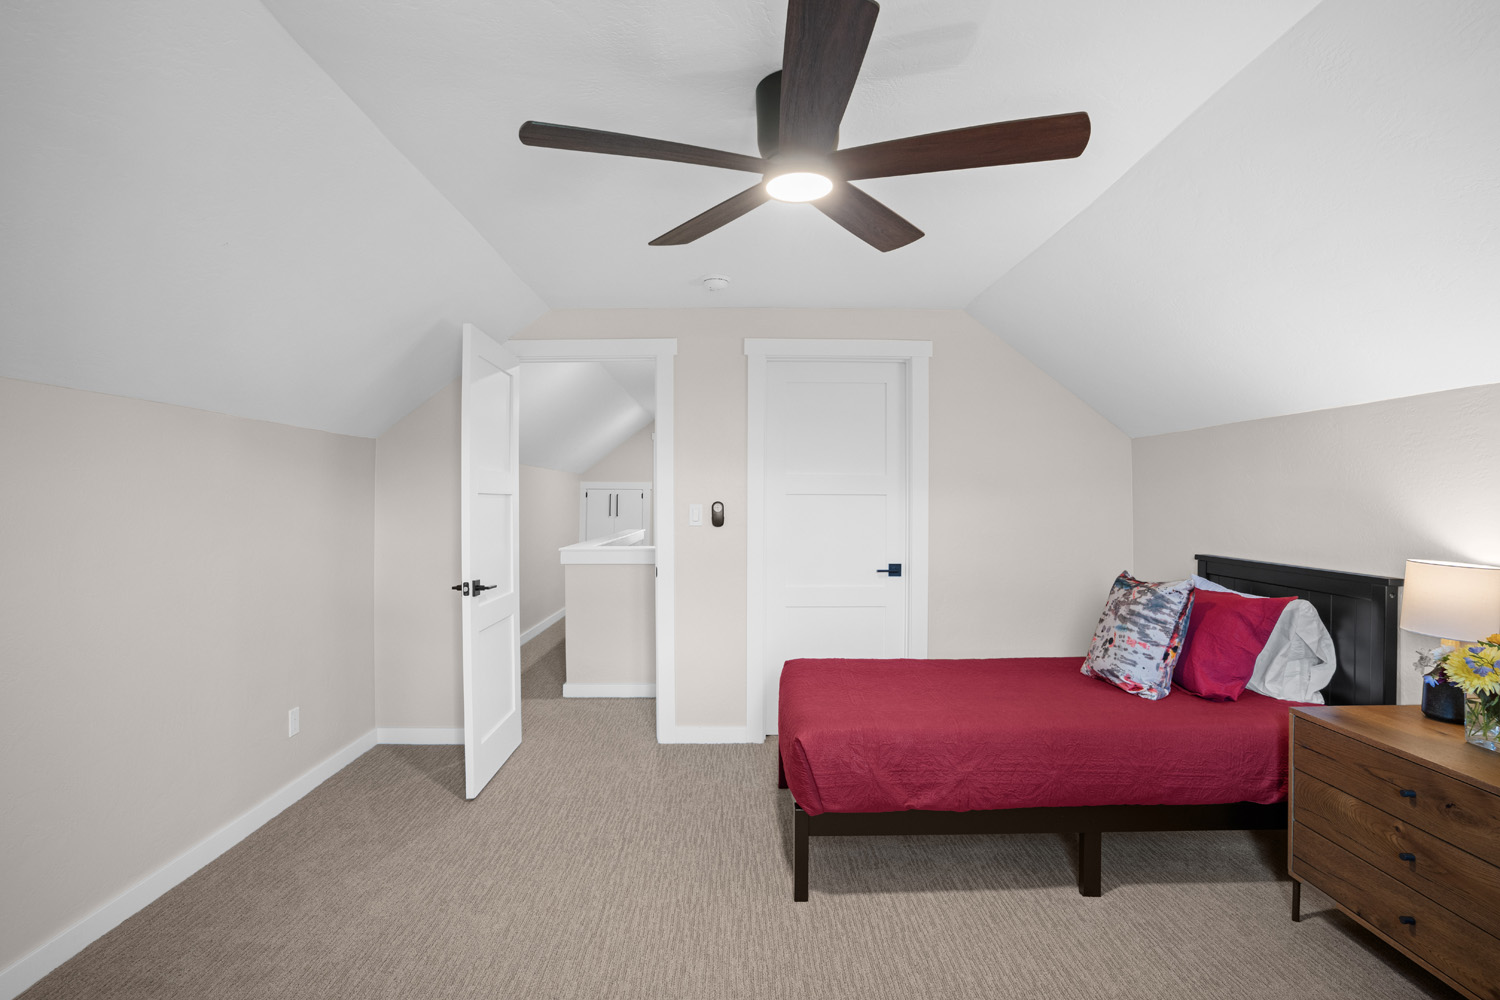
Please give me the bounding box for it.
[564,565,656,684]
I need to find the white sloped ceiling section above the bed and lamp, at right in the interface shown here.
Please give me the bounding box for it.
[971,0,1500,436]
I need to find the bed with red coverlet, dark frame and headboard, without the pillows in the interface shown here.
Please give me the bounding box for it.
[779,555,1401,901]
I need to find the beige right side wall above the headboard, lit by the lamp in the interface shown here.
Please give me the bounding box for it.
[1134,385,1500,702]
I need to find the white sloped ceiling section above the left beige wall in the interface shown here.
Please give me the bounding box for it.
[0,0,546,436]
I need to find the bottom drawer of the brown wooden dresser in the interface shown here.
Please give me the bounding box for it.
[1292,823,1500,1000]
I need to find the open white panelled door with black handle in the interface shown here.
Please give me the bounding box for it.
[459,324,521,799]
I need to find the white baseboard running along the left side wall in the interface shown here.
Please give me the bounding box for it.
[0,730,375,1000]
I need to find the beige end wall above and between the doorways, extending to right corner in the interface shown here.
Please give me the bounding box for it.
[518,309,1131,726]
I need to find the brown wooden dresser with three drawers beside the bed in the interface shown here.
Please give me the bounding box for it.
[1289,705,1500,1000]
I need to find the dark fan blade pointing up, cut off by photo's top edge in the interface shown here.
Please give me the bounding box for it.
[780,0,881,154]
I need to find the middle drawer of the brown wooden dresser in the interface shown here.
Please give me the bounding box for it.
[1292,760,1500,937]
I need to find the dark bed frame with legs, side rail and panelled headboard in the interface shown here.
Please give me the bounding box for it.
[777,555,1401,903]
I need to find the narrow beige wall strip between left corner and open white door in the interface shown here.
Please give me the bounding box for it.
[374,379,464,727]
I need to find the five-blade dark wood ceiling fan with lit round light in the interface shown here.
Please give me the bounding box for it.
[521,0,1089,252]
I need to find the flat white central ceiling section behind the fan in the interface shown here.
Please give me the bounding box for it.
[267,0,1316,309]
